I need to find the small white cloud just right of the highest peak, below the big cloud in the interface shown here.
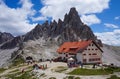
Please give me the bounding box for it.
[81,14,101,25]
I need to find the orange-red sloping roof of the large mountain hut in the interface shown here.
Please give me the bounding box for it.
[57,40,92,54]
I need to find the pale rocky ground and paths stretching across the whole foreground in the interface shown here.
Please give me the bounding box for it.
[0,61,120,79]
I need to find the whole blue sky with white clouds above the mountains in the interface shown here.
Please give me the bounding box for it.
[0,0,120,46]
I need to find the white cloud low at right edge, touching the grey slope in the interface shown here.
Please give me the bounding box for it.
[95,29,120,46]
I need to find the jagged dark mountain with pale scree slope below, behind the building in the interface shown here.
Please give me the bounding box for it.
[0,7,118,67]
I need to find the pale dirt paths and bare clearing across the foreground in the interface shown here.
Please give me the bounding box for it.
[0,62,120,79]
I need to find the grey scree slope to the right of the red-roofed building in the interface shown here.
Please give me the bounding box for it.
[102,45,120,66]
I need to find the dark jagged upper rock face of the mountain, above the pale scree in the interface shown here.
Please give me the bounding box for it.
[0,8,96,49]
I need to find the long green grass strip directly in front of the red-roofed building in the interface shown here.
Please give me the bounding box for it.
[68,68,114,75]
